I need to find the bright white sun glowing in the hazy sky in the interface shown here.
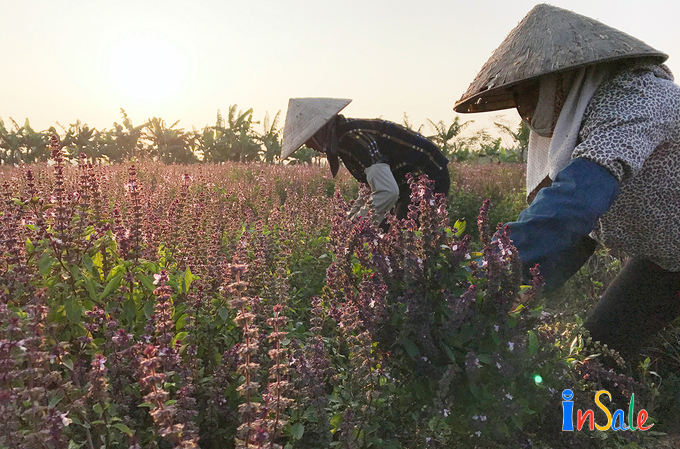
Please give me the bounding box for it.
[105,34,189,104]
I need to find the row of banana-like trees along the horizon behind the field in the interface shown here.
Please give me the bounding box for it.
[0,105,529,165]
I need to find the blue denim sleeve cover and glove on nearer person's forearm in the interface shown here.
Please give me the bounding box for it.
[508,158,619,289]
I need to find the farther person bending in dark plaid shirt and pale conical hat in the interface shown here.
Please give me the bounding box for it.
[281,98,450,227]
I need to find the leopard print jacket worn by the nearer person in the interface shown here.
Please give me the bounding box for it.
[572,65,680,271]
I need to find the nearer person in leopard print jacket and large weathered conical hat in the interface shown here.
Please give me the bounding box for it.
[454,5,680,358]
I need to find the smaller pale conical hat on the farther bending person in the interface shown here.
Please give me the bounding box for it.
[281,98,352,159]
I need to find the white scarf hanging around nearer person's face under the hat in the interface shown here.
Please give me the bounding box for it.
[527,64,608,197]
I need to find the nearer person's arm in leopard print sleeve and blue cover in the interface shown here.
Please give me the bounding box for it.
[510,66,680,288]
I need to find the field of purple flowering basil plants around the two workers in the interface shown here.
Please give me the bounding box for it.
[0,139,676,449]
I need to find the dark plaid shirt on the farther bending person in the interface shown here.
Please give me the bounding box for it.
[337,115,449,194]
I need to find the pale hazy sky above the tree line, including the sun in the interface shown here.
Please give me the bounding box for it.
[0,0,680,136]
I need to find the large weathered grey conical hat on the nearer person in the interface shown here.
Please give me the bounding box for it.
[453,4,668,112]
